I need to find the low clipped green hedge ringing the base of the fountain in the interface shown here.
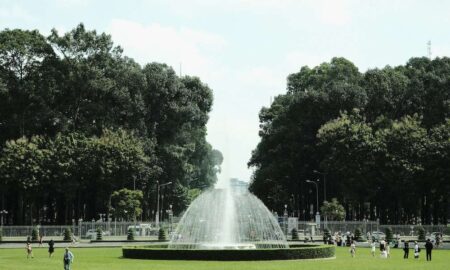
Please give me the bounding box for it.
[122,245,335,261]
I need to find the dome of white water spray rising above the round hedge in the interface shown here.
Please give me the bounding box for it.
[168,176,289,249]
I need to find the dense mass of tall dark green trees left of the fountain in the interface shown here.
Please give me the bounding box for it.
[0,24,222,224]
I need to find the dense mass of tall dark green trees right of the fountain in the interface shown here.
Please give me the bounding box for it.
[249,57,450,224]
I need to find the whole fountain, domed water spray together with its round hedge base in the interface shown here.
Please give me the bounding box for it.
[122,176,335,261]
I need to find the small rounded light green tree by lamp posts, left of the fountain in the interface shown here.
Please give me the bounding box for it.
[111,188,143,220]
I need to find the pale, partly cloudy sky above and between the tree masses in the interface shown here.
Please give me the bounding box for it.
[0,0,450,181]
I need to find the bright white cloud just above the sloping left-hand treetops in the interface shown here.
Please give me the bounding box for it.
[108,20,226,76]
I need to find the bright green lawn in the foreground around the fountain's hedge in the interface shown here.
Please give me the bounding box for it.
[0,248,450,270]
